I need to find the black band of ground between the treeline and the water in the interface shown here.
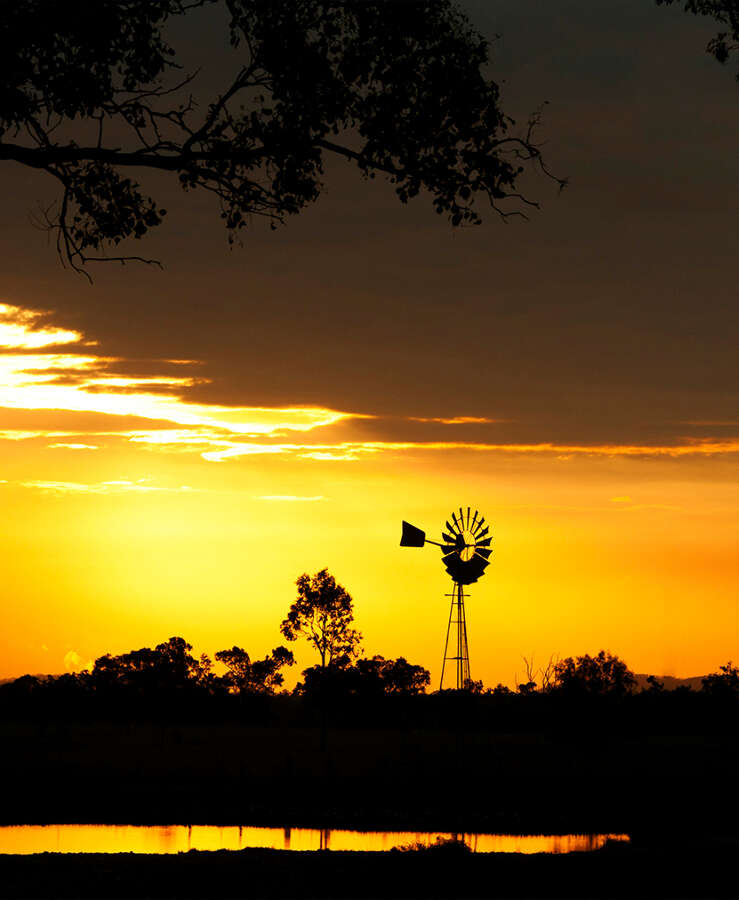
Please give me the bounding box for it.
[0,722,739,839]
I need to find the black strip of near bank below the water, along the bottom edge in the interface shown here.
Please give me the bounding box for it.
[0,846,739,900]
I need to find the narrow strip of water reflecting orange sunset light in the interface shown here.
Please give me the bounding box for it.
[0,825,629,854]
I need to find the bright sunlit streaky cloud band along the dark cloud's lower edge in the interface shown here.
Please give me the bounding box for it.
[0,304,739,464]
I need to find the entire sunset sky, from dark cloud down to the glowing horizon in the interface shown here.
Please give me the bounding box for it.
[0,0,739,686]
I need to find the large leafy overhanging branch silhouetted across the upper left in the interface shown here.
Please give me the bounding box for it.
[0,0,564,271]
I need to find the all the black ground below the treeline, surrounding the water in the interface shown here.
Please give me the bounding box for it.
[0,721,739,900]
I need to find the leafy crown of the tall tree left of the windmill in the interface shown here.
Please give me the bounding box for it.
[280,569,362,668]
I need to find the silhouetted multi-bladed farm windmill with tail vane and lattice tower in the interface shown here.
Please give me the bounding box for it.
[400,506,493,691]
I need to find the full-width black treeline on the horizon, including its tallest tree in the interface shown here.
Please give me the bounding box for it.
[0,569,739,733]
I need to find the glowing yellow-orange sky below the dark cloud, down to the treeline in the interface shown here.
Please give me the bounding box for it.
[0,304,739,684]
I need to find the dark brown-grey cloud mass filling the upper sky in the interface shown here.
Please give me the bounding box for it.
[0,0,739,444]
